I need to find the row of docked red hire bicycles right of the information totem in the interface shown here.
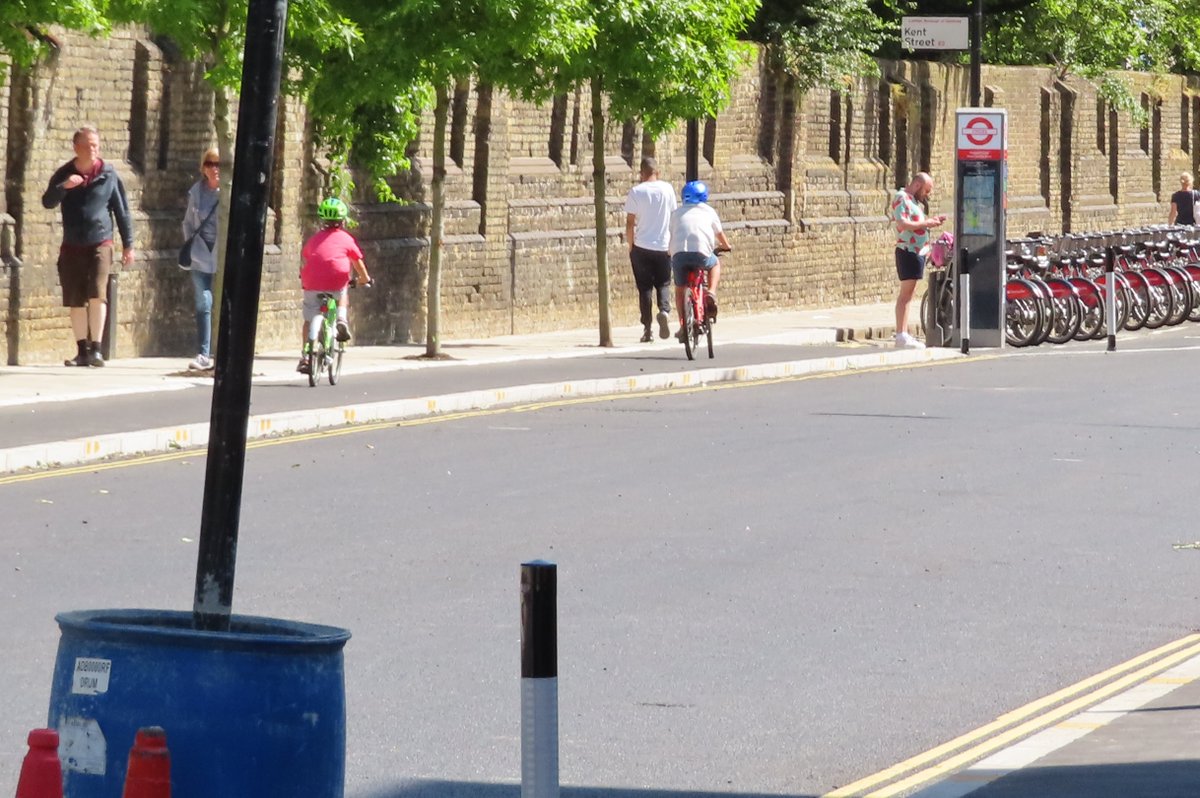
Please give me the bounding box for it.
[936,226,1200,347]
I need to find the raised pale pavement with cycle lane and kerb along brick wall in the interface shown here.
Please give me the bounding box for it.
[0,298,958,473]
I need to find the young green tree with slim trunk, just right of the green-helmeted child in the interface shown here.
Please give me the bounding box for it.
[311,0,590,358]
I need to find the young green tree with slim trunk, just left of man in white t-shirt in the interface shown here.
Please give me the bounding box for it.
[558,0,758,347]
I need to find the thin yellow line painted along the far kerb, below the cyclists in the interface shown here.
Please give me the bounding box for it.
[0,354,974,486]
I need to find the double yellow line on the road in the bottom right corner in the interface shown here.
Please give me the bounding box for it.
[822,635,1200,798]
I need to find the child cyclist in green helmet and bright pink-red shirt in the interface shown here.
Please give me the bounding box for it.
[296,197,371,374]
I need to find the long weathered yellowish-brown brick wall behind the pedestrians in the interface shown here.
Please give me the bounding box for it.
[0,28,1180,362]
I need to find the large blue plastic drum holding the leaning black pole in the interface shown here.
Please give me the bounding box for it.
[49,610,350,798]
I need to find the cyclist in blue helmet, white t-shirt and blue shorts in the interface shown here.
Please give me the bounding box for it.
[671,180,732,341]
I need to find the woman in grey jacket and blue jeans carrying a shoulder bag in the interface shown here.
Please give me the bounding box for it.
[184,148,221,371]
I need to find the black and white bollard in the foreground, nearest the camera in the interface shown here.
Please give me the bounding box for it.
[521,560,558,798]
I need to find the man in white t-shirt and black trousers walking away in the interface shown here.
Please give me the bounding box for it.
[625,157,676,343]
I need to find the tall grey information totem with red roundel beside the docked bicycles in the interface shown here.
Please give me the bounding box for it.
[925,108,1008,352]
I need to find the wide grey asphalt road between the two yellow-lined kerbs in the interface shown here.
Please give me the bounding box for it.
[0,335,1200,798]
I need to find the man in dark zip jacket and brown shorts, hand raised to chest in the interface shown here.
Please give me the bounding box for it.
[42,127,133,366]
